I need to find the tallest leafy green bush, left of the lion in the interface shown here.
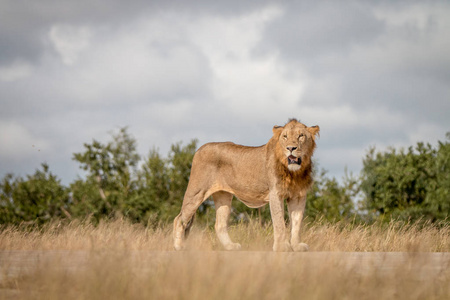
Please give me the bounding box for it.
[71,128,140,220]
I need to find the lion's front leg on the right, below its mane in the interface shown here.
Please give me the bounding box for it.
[288,196,309,251]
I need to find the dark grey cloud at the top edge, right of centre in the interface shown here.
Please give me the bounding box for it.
[264,1,384,60]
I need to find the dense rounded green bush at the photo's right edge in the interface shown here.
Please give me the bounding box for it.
[361,134,450,221]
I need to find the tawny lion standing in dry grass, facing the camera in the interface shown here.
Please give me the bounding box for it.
[173,119,319,251]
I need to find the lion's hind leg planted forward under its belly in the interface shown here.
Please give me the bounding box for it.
[212,192,241,250]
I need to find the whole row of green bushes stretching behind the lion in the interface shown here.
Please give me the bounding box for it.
[0,128,450,228]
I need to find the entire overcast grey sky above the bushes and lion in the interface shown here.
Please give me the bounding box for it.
[0,0,450,184]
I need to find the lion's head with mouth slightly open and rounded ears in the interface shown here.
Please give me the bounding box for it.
[273,119,320,172]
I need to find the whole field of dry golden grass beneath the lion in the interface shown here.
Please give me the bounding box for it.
[0,220,450,299]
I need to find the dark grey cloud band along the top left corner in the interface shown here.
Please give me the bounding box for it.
[0,0,271,65]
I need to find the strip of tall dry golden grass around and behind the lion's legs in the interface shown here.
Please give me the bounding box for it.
[0,220,450,252]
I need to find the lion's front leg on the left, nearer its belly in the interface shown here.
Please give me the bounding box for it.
[269,193,291,251]
